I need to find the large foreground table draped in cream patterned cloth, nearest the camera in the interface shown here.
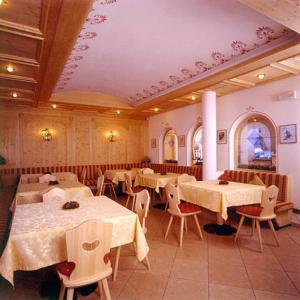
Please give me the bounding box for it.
[0,196,149,285]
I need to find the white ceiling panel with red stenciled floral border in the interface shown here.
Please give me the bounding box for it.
[54,0,293,105]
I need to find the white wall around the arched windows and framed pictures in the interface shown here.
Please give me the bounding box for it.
[148,76,300,208]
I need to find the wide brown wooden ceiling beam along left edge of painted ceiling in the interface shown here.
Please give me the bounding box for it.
[36,0,94,104]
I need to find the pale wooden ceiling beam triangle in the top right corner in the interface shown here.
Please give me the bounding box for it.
[239,0,300,33]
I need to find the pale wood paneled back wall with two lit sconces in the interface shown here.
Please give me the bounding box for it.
[0,108,147,168]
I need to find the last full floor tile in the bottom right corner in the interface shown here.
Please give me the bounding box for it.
[247,267,298,295]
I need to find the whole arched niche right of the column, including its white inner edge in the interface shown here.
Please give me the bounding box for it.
[229,111,278,171]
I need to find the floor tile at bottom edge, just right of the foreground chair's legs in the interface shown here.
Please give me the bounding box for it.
[120,271,168,300]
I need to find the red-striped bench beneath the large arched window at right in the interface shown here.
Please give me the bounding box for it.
[224,170,294,227]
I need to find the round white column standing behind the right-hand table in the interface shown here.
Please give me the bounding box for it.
[202,91,217,180]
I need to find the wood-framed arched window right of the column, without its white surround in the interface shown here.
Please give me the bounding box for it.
[235,115,276,171]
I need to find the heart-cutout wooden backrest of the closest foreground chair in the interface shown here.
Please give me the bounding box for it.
[66,220,112,282]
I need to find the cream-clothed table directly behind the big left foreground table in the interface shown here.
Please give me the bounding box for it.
[10,180,93,211]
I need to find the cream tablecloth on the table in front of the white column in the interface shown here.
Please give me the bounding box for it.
[179,180,265,220]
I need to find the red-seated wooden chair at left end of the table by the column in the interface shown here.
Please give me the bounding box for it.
[165,183,203,248]
